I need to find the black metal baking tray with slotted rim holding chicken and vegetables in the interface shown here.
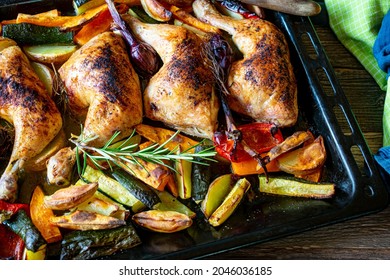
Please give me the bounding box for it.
[0,1,389,259]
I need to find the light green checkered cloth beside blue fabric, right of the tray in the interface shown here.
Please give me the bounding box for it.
[325,0,390,146]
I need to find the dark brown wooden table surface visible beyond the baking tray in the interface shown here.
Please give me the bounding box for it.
[212,17,390,260]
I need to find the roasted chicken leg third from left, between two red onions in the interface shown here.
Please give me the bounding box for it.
[124,16,219,138]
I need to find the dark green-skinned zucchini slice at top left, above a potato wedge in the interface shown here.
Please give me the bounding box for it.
[2,23,74,45]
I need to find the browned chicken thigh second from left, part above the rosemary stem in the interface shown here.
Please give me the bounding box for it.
[59,32,142,146]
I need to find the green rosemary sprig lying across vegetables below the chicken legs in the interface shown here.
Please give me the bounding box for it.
[70,127,216,178]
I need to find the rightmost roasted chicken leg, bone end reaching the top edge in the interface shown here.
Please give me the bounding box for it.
[193,0,298,127]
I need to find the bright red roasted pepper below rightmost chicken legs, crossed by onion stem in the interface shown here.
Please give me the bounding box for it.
[213,123,283,162]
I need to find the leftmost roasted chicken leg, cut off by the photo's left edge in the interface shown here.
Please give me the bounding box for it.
[0,43,62,202]
